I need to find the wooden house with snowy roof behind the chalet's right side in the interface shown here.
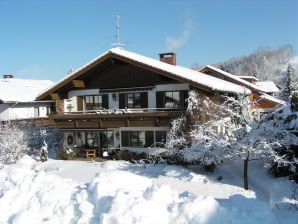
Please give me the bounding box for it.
[199,65,284,118]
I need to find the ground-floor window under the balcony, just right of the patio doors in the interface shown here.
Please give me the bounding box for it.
[121,131,154,147]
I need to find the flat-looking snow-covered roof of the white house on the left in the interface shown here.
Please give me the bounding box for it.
[0,78,53,102]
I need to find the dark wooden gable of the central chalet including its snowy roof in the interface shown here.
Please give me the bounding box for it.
[36,48,250,100]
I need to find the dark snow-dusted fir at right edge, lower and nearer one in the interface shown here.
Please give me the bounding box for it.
[258,105,298,179]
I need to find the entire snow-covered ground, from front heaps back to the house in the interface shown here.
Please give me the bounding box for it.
[0,156,298,224]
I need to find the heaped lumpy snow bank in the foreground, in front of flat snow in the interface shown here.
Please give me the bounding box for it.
[0,156,275,224]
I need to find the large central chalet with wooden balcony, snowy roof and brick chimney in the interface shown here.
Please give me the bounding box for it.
[36,48,251,155]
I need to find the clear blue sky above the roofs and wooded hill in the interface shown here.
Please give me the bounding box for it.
[0,0,298,81]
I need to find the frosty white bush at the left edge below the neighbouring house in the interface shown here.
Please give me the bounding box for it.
[0,123,29,166]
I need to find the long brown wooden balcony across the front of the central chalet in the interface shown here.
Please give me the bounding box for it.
[49,108,185,129]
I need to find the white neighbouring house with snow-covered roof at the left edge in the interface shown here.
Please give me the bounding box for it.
[0,75,53,122]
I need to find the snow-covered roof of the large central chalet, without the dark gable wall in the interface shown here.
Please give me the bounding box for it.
[38,48,251,99]
